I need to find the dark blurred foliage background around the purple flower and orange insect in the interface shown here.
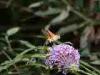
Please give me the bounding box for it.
[0,0,100,75]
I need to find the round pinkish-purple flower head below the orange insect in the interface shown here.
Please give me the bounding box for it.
[45,43,80,74]
